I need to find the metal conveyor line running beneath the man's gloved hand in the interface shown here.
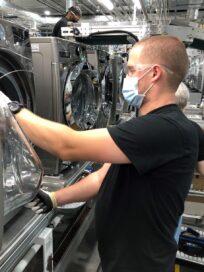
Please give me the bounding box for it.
[0,162,97,272]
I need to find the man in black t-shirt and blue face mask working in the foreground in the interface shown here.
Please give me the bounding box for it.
[11,36,198,272]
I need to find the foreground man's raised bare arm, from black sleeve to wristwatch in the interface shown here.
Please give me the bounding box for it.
[16,109,129,163]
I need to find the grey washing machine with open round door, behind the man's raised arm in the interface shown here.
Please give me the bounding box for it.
[31,37,101,175]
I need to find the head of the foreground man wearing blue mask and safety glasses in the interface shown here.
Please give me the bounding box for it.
[123,35,189,109]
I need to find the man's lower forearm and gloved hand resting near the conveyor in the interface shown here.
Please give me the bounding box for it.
[29,163,111,213]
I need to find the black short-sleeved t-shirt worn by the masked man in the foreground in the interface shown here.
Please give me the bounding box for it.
[95,104,198,272]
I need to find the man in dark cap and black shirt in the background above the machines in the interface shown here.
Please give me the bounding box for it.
[52,7,82,38]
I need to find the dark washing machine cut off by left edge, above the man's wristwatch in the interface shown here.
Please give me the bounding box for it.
[0,20,35,111]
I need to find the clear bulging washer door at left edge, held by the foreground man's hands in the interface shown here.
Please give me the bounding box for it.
[0,93,43,223]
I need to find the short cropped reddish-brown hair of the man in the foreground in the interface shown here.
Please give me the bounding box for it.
[134,35,189,90]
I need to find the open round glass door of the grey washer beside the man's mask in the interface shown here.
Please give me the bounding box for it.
[64,63,100,130]
